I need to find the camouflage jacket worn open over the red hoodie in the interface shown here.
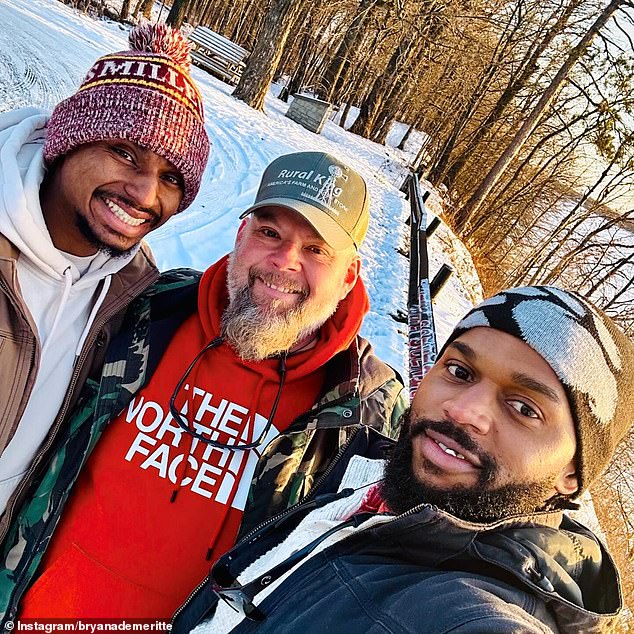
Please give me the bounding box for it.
[0,269,407,624]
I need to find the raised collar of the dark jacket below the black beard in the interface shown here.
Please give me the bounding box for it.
[364,504,622,632]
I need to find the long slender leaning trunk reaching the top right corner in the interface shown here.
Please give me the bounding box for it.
[456,0,628,227]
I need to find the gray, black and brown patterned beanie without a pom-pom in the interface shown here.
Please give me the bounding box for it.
[439,286,634,496]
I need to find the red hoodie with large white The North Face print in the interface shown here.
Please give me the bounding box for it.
[20,258,368,619]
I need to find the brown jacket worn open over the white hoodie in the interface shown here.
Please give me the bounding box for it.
[0,235,159,540]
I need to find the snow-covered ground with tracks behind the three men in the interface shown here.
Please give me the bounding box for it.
[0,0,481,376]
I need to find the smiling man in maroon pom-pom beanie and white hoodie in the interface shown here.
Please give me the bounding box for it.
[0,24,209,524]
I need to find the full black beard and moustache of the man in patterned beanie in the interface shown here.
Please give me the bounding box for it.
[381,411,554,523]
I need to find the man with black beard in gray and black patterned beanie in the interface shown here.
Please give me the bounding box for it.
[173,286,634,634]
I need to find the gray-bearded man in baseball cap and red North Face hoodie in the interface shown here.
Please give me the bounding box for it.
[7,152,405,619]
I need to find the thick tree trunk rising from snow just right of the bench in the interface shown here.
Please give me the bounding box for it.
[233,0,300,110]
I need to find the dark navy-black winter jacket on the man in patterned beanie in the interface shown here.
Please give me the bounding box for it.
[174,428,622,634]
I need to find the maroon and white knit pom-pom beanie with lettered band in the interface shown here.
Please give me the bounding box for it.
[44,23,209,211]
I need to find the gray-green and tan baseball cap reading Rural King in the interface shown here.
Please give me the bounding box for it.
[240,152,370,249]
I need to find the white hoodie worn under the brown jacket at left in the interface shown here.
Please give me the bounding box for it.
[0,108,138,514]
